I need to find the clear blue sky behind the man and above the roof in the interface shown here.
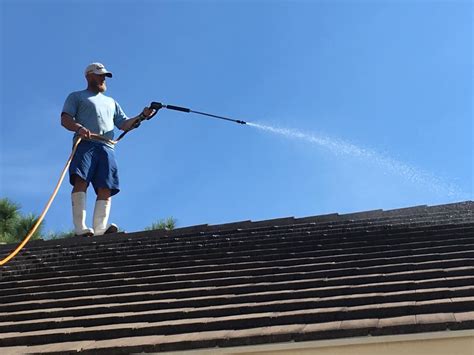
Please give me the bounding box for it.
[0,0,474,236]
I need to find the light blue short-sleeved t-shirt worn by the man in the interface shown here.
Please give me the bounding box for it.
[63,89,128,145]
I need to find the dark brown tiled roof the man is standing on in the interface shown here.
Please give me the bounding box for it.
[0,201,474,354]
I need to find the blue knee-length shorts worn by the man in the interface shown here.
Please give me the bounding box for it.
[69,141,120,196]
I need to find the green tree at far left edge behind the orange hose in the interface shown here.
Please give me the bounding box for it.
[0,198,43,244]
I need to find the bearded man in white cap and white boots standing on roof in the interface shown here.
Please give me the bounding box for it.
[61,63,154,236]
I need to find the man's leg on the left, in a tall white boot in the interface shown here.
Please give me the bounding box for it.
[71,175,94,237]
